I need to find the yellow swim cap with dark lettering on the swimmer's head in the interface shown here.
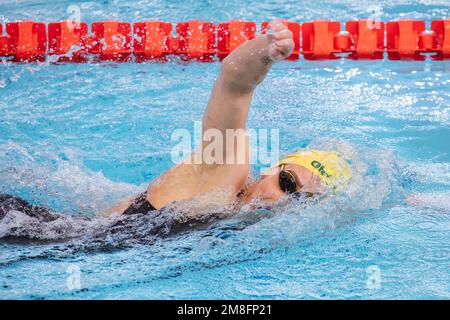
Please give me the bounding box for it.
[272,150,352,191]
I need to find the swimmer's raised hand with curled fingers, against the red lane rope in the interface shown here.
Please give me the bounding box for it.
[267,20,294,61]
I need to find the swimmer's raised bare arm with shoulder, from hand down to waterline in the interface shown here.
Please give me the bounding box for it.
[137,21,294,209]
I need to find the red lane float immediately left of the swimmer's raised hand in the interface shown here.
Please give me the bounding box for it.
[217,20,256,60]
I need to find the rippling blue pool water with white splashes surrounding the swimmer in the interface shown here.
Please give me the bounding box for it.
[0,0,450,299]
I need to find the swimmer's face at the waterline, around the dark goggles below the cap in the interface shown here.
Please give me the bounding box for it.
[244,164,324,204]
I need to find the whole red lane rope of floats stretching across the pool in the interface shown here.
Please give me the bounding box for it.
[0,19,450,62]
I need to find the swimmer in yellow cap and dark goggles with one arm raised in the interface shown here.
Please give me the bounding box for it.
[106,20,350,215]
